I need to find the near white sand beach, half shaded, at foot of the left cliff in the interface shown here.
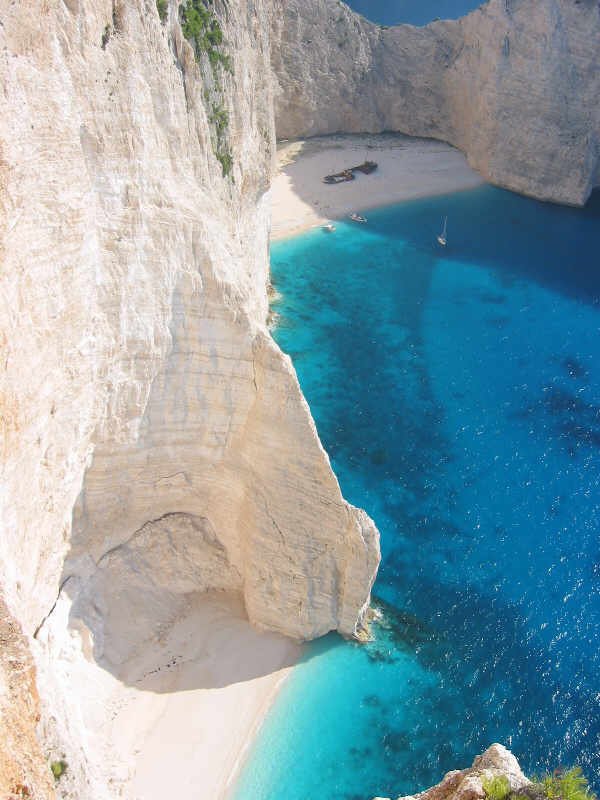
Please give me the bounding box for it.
[116,595,298,800]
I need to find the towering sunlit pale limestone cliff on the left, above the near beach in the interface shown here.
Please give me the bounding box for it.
[0,0,379,800]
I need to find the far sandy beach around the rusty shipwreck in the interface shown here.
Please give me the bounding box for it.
[271,134,483,239]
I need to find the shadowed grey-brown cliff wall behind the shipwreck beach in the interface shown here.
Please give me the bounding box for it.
[272,0,600,205]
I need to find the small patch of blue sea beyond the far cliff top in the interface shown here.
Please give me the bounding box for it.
[348,0,482,25]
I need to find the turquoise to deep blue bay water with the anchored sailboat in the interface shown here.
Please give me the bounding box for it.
[235,187,600,800]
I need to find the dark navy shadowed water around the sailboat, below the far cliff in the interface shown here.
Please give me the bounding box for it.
[369,186,600,305]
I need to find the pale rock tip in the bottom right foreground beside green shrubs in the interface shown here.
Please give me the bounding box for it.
[375,744,531,800]
